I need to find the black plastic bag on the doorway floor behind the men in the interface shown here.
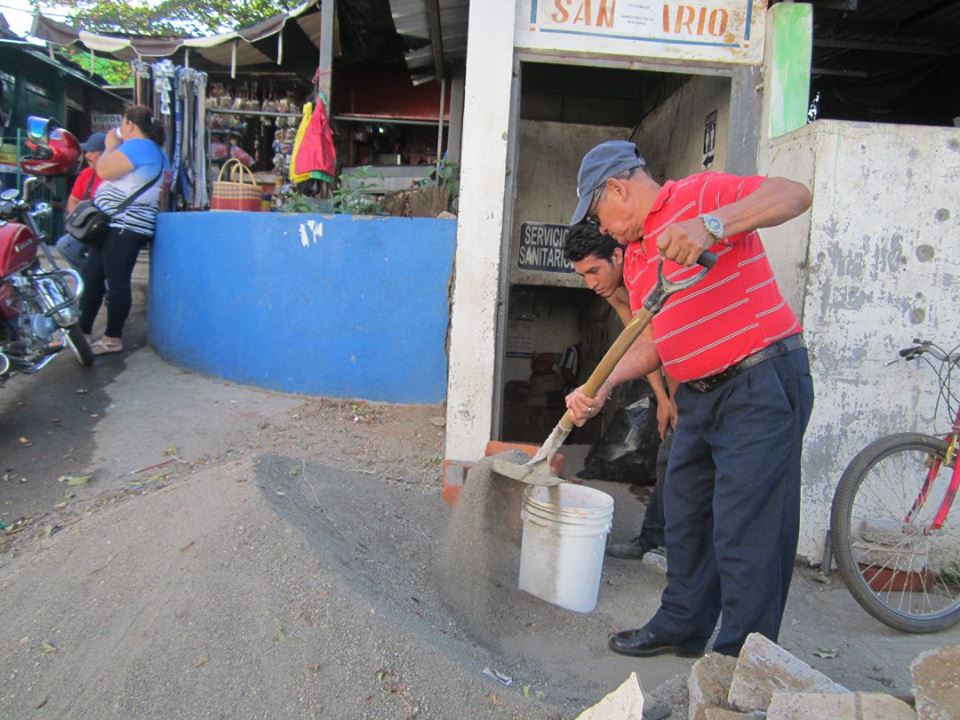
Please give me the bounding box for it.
[577,380,660,485]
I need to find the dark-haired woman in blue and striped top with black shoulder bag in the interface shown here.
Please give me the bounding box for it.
[80,105,170,355]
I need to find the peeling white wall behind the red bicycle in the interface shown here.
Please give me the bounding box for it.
[760,121,960,561]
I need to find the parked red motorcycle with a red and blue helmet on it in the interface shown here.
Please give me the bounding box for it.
[0,117,93,385]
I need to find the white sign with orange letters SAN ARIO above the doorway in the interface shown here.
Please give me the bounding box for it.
[514,0,767,65]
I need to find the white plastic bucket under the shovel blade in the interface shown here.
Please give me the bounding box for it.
[520,483,613,613]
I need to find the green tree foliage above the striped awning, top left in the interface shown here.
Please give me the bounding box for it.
[32,0,300,36]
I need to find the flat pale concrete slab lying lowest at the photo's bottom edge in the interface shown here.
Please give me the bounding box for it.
[767,691,917,720]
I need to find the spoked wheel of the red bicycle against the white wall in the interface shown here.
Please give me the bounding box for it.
[830,433,960,633]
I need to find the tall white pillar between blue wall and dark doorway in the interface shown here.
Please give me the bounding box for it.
[445,0,516,461]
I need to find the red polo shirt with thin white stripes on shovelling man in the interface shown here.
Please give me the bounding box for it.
[623,173,801,382]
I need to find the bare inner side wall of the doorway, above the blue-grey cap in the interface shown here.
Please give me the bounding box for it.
[635,75,730,182]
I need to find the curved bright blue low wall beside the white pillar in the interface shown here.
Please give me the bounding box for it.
[149,212,456,403]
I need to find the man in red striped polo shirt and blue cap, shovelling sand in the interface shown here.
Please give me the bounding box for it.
[567,141,813,657]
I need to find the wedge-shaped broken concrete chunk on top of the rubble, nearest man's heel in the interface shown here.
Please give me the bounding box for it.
[727,633,849,717]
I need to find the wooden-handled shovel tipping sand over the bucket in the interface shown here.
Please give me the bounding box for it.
[493,251,717,487]
